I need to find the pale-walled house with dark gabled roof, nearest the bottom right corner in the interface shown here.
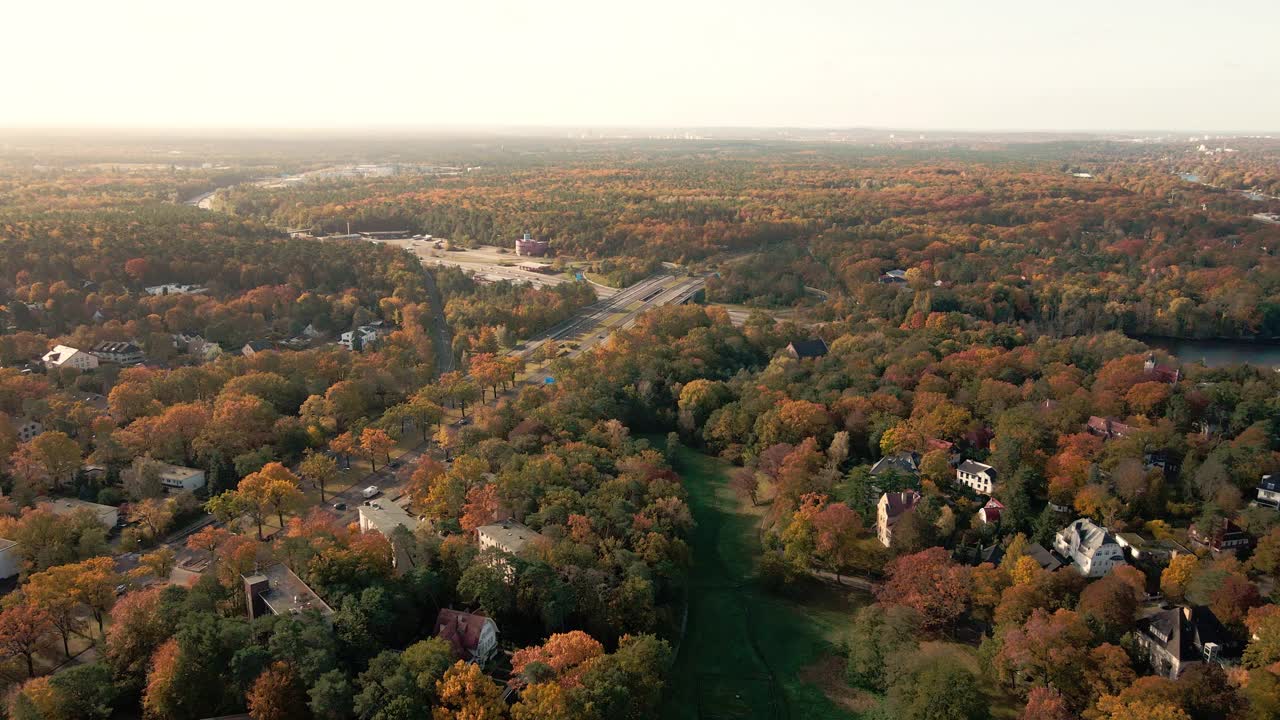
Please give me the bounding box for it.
[1134,606,1238,679]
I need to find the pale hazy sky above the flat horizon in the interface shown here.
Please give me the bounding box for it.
[0,0,1280,132]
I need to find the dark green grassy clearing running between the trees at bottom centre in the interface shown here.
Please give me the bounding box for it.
[663,448,868,720]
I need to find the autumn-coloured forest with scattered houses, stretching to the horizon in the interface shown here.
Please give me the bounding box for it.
[0,140,1280,720]
